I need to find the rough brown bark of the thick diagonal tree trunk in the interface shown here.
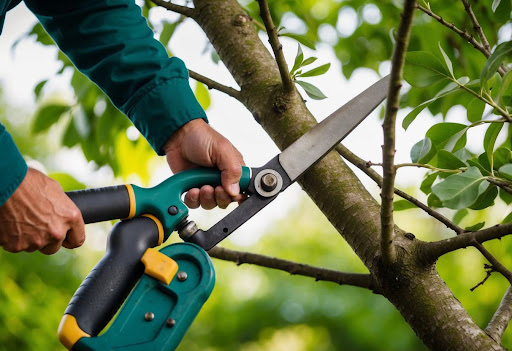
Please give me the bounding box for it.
[189,0,503,351]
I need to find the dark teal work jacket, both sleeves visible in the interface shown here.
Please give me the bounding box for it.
[0,0,206,206]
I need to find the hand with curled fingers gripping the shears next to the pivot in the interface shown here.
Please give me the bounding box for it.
[164,119,245,210]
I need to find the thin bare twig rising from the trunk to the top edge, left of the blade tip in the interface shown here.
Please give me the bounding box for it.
[258,0,294,94]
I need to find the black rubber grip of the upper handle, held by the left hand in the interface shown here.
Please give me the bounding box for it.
[66,185,130,223]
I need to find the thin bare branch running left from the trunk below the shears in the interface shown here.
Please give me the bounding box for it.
[208,247,374,291]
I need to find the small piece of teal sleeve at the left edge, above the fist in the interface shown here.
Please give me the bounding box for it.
[0,123,27,206]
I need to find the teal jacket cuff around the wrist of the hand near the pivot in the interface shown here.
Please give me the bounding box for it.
[126,63,208,156]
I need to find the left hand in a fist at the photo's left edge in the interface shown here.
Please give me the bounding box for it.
[0,168,85,255]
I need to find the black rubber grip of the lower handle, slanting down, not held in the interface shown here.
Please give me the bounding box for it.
[64,217,158,336]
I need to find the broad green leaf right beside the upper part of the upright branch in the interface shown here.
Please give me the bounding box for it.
[404,51,451,88]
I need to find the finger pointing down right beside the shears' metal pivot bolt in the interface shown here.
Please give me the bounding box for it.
[214,139,243,196]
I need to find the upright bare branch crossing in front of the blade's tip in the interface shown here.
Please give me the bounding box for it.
[380,0,416,263]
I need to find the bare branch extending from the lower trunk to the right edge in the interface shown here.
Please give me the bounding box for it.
[423,223,512,262]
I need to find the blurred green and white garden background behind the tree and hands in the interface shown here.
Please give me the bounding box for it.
[0,0,512,351]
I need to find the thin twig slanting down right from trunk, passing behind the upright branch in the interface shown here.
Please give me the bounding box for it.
[336,144,464,233]
